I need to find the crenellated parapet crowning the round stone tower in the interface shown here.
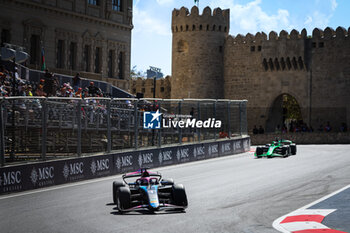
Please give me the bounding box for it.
[171,6,230,34]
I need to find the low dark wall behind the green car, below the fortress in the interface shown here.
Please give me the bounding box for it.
[250,133,350,145]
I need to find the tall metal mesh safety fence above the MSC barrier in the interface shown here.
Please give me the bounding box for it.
[0,97,247,166]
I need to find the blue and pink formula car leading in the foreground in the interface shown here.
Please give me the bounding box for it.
[113,169,188,213]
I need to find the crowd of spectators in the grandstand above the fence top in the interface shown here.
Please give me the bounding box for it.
[0,66,110,98]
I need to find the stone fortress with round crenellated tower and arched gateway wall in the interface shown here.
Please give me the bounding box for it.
[171,6,350,131]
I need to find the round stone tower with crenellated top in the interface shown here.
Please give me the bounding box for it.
[171,6,230,99]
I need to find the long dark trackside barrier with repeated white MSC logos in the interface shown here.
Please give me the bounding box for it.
[0,136,250,195]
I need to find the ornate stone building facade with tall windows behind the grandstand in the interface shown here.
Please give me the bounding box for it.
[0,0,133,90]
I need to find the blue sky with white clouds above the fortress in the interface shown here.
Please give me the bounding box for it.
[131,0,350,75]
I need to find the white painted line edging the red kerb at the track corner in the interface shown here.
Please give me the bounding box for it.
[272,185,350,233]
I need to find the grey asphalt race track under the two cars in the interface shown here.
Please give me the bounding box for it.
[0,145,350,233]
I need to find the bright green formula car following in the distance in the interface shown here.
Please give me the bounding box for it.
[254,140,297,158]
